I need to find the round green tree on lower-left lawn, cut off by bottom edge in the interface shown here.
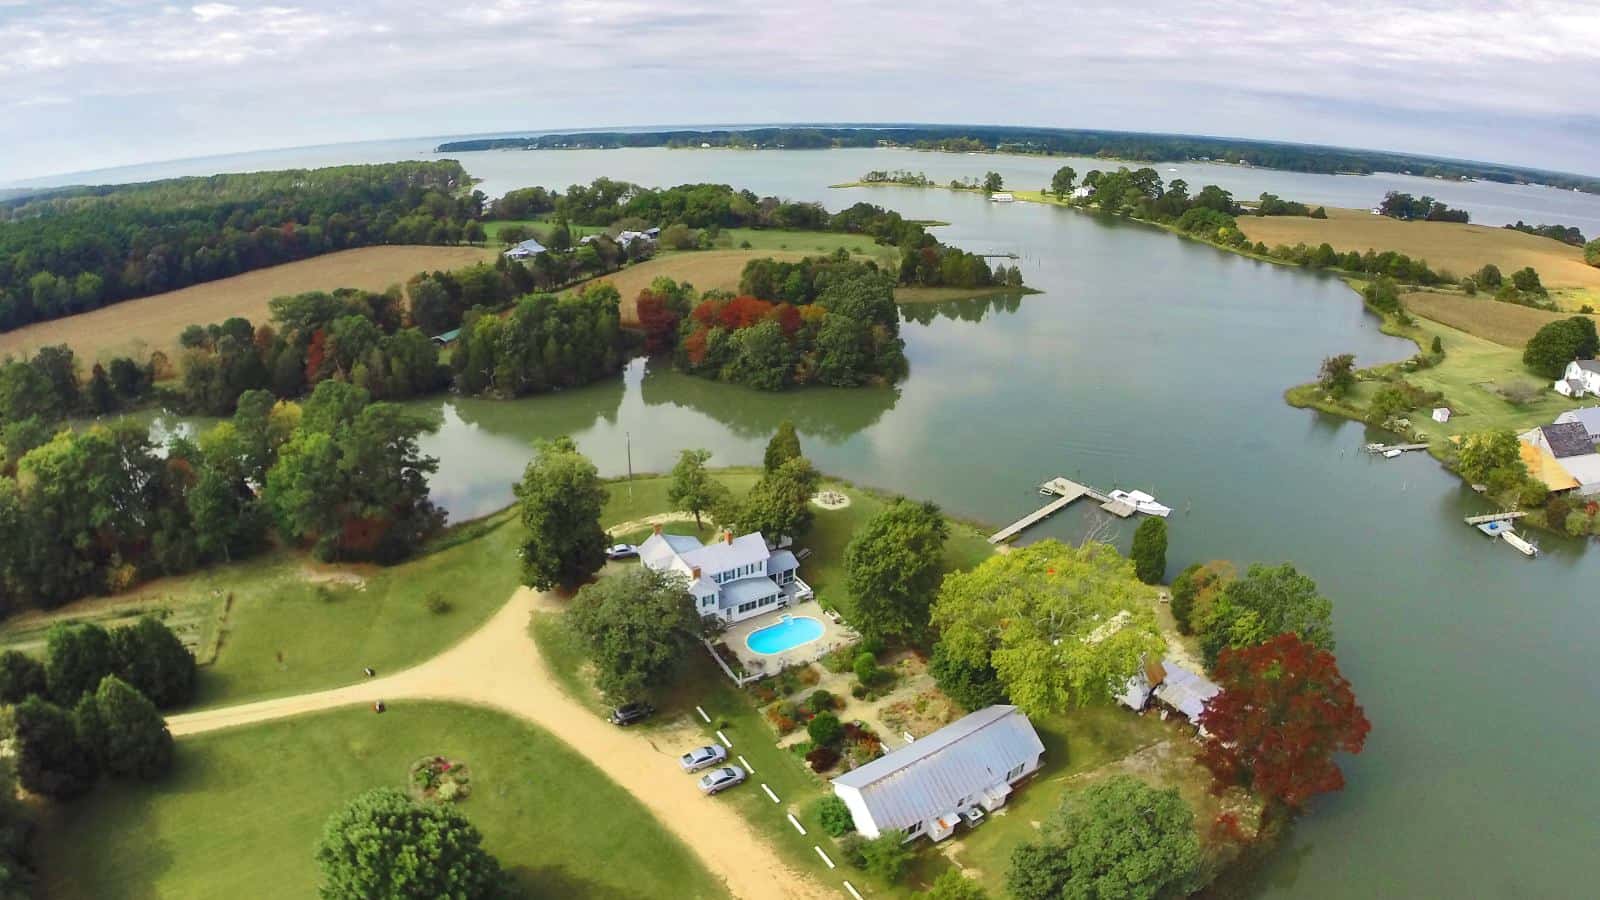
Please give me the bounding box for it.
[317,788,509,900]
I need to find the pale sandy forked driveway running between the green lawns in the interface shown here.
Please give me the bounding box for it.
[168,588,838,900]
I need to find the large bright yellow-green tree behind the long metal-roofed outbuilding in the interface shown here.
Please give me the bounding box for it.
[933,540,1165,714]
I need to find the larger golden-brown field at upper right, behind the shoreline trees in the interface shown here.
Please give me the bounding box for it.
[1238,210,1600,302]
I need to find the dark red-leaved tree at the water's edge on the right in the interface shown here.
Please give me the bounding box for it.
[1198,634,1371,815]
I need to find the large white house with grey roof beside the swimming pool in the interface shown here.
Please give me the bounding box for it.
[638,525,814,625]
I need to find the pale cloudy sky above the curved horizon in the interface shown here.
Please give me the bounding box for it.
[0,0,1600,184]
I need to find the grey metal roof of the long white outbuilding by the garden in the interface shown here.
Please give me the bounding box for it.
[834,705,1045,830]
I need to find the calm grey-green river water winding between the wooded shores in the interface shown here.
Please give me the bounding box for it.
[124,147,1600,897]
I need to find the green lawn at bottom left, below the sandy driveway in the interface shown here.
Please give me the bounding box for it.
[35,703,726,900]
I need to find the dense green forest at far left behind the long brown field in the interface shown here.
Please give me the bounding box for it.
[0,160,483,330]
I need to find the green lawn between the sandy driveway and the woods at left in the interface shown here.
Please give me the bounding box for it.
[0,514,522,708]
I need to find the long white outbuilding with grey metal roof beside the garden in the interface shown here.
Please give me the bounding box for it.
[834,706,1045,841]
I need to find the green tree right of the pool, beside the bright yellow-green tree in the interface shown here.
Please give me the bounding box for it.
[845,500,950,639]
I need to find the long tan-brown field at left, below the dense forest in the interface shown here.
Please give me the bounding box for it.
[0,247,496,364]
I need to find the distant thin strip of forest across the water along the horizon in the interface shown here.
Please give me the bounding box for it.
[437,125,1600,194]
